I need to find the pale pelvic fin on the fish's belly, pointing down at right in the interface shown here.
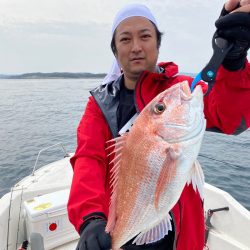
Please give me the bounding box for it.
[187,160,205,200]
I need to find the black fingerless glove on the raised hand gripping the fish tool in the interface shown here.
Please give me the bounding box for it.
[215,6,250,71]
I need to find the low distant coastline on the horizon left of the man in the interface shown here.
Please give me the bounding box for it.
[0,72,106,79]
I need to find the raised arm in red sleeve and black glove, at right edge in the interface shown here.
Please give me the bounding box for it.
[204,0,250,134]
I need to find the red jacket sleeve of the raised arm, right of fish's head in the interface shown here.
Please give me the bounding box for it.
[204,62,250,134]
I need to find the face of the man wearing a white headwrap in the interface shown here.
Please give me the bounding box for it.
[115,17,158,78]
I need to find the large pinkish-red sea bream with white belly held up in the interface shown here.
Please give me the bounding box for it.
[105,81,206,250]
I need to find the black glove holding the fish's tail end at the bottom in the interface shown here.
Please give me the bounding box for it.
[76,218,111,250]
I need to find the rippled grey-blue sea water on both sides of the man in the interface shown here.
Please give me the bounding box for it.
[0,79,250,210]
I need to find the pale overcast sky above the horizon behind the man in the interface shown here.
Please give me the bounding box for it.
[0,0,248,74]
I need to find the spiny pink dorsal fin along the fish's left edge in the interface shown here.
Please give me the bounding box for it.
[106,133,128,233]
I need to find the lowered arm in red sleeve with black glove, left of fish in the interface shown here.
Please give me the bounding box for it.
[68,97,111,250]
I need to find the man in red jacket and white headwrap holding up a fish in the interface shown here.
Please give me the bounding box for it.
[68,0,250,250]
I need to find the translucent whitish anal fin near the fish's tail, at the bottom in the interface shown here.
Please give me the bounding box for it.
[133,214,172,245]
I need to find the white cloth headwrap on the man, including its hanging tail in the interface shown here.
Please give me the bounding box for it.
[102,4,157,84]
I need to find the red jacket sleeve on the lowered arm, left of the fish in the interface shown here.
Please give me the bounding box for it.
[68,97,111,232]
